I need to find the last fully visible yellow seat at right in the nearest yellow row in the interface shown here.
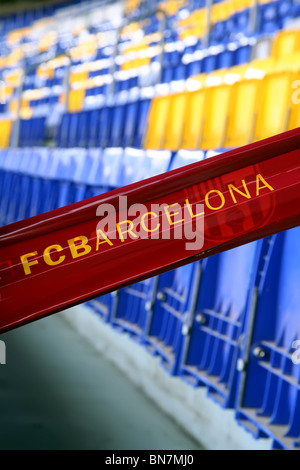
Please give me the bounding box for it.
[254,72,294,141]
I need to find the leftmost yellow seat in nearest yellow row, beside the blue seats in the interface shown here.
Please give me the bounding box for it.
[144,95,171,150]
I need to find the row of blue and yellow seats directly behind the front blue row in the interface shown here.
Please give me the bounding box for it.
[46,55,300,151]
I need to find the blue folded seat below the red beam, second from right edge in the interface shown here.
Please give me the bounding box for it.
[180,242,262,407]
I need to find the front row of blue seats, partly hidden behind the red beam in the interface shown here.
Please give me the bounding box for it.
[0,148,300,449]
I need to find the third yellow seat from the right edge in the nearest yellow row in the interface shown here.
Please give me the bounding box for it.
[223,79,261,148]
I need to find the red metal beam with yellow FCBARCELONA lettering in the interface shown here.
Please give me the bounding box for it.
[0,129,300,331]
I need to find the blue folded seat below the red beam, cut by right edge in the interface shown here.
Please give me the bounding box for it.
[236,227,300,449]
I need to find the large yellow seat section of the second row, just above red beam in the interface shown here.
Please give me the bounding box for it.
[144,54,300,151]
